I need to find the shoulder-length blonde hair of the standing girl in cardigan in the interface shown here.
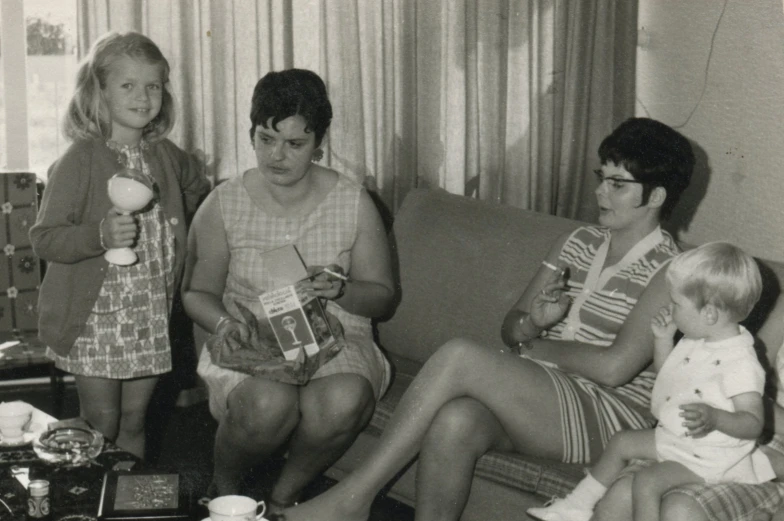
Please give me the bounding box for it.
[63,32,174,142]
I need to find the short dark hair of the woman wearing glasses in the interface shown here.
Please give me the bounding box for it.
[599,118,694,220]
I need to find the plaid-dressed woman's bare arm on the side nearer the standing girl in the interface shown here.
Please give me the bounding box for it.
[182,192,236,333]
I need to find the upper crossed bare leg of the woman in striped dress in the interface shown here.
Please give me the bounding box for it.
[286,339,563,521]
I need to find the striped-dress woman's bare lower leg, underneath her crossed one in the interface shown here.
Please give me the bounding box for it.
[415,398,513,521]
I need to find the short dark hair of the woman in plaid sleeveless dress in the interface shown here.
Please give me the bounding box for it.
[250,69,332,146]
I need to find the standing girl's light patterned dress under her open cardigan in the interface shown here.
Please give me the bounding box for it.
[47,141,174,379]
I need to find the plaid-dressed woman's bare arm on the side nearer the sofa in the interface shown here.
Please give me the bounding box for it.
[328,190,394,318]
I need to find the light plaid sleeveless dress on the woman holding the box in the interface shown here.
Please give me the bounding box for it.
[198,175,391,419]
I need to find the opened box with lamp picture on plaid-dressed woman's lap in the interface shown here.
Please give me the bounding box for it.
[259,244,336,360]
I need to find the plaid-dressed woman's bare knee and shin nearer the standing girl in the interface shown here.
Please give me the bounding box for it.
[210,378,299,495]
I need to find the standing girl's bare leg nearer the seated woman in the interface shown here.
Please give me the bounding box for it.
[117,376,158,459]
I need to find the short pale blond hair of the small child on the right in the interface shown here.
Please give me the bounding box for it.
[667,242,762,322]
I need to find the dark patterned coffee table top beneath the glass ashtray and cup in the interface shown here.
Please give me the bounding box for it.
[0,436,144,521]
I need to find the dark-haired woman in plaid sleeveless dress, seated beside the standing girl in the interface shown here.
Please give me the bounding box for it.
[183,69,394,513]
